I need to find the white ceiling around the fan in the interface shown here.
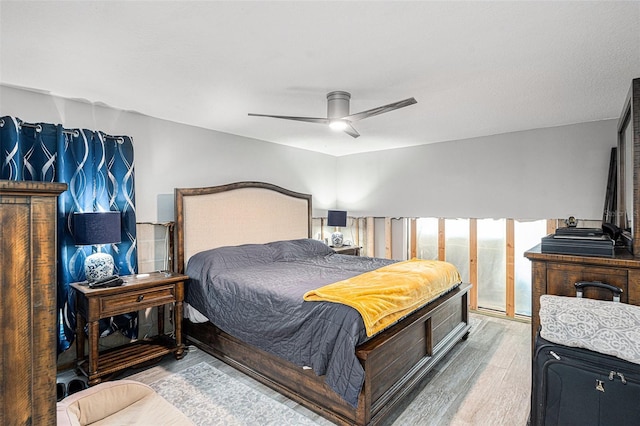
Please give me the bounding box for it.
[0,0,640,155]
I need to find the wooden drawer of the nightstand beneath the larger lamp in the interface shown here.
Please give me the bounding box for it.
[100,285,176,317]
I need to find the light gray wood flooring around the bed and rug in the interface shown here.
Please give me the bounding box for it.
[118,313,531,426]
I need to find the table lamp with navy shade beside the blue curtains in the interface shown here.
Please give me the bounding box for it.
[73,211,121,282]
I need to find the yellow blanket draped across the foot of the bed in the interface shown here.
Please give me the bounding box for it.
[304,259,461,336]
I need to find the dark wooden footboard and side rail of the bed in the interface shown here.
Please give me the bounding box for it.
[185,284,471,425]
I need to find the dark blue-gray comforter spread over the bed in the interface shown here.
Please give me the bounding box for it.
[186,239,394,407]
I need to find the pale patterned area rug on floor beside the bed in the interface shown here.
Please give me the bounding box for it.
[150,362,317,426]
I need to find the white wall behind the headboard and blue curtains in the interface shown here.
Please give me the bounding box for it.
[0,85,336,222]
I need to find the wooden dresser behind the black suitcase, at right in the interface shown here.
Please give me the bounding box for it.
[524,245,640,342]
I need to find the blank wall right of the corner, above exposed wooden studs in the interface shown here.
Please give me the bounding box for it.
[337,120,617,219]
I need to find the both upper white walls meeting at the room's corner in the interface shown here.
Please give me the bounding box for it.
[0,85,617,222]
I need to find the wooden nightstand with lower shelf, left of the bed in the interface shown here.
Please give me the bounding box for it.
[71,272,189,385]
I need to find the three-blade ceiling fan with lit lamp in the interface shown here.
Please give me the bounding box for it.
[249,90,417,138]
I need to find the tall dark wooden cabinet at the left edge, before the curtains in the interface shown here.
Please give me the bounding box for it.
[0,180,67,426]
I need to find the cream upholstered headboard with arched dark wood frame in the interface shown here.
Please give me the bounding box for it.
[174,182,311,272]
